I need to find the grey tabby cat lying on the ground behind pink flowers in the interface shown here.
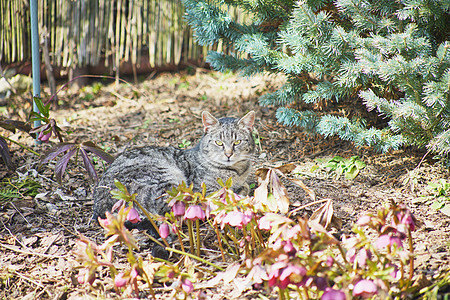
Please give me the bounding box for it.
[93,111,255,220]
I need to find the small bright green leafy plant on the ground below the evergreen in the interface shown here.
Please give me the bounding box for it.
[311,156,366,179]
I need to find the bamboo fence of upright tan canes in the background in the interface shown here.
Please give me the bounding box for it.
[0,0,245,69]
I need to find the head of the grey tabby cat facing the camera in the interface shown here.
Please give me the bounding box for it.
[200,111,255,166]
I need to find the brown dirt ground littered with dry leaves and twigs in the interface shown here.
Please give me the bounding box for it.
[0,69,450,299]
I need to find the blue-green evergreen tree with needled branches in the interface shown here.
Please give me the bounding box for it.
[183,0,450,155]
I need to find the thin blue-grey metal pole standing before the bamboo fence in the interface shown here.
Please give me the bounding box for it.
[30,0,41,138]
